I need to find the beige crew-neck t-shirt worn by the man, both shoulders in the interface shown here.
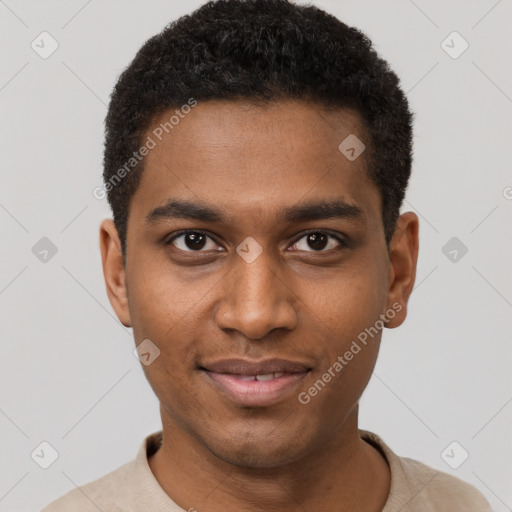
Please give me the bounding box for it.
[42,430,491,512]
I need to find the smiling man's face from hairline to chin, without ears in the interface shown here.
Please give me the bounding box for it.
[106,101,410,467]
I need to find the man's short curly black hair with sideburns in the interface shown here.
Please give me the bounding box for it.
[103,0,413,256]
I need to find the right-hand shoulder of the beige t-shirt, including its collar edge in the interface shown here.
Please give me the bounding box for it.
[360,430,491,512]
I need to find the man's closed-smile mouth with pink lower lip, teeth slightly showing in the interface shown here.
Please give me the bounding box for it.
[199,359,312,407]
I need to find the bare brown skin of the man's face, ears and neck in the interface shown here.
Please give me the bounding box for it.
[100,100,418,512]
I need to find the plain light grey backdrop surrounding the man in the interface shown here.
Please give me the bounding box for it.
[0,0,512,512]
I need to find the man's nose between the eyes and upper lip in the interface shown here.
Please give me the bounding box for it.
[216,251,297,340]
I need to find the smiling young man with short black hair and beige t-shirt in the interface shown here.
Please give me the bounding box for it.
[45,0,489,512]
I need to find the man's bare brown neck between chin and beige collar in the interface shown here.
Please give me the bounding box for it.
[148,406,390,512]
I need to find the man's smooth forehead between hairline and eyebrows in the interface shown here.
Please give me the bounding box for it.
[132,100,380,226]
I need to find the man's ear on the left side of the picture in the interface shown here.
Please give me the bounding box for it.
[100,219,131,327]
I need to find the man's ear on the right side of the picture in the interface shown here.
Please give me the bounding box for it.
[386,212,419,328]
